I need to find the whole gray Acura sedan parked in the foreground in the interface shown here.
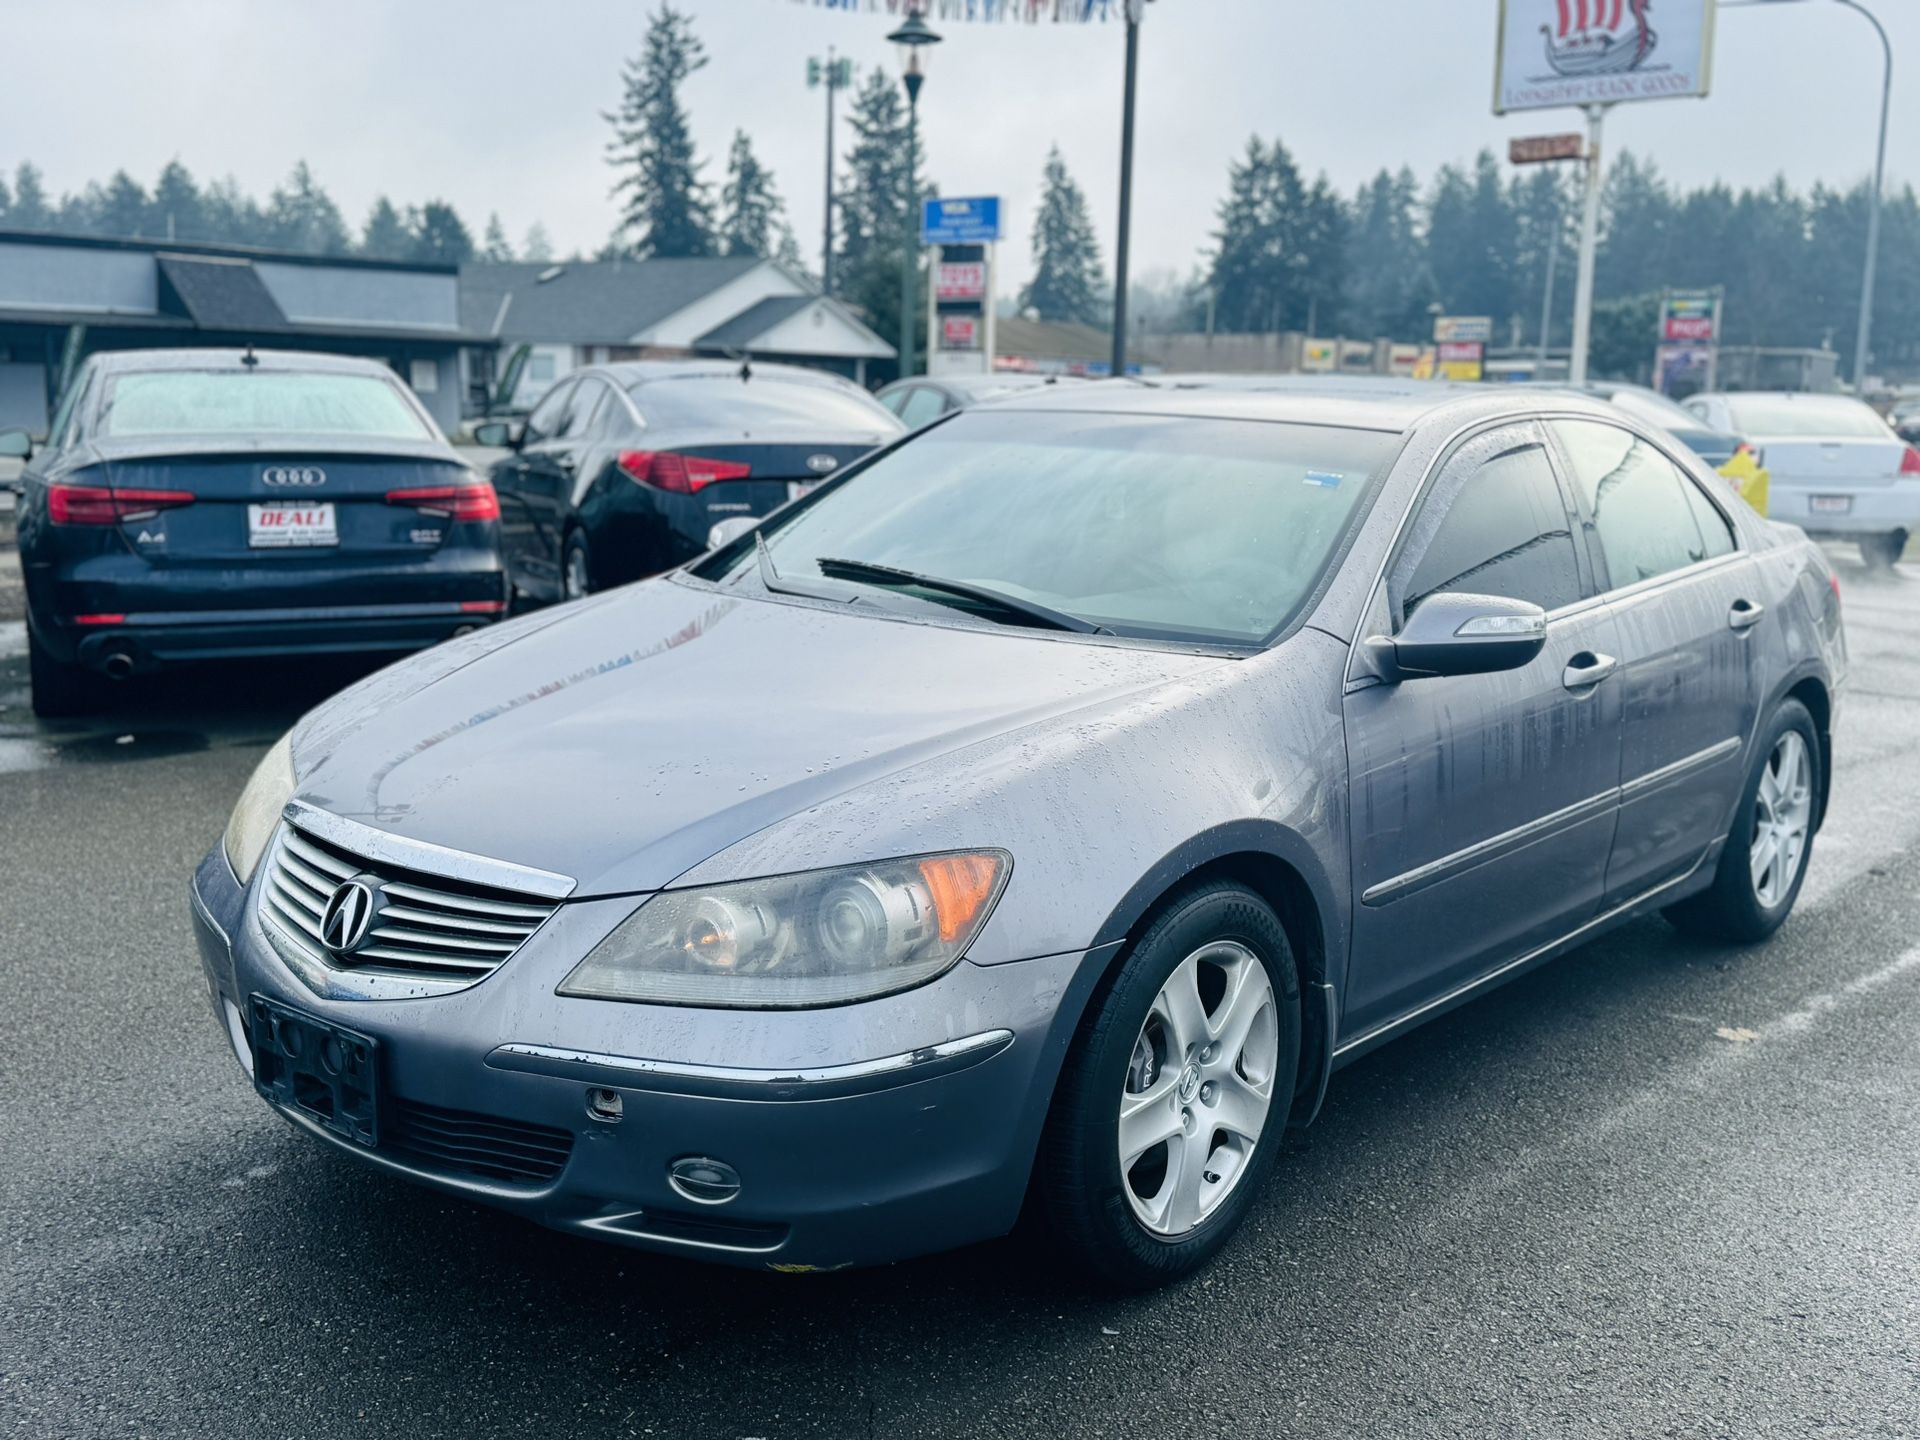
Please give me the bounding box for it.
[192,384,1845,1286]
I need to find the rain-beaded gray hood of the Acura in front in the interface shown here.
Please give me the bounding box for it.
[294,580,1223,897]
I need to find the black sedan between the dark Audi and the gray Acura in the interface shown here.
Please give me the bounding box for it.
[474,361,902,601]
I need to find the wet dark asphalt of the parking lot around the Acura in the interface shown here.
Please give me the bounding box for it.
[0,557,1920,1440]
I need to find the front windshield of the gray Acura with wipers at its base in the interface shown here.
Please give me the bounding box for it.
[735,411,1398,645]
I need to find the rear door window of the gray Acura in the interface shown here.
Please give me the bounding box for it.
[1551,420,1732,589]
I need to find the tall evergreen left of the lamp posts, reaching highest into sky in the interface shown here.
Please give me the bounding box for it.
[607,0,714,255]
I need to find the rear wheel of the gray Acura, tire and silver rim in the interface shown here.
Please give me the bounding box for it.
[1665,701,1820,945]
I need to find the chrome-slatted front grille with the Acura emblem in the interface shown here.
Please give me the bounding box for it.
[261,826,557,983]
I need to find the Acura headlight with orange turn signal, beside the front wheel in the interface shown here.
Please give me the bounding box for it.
[559,851,1014,1010]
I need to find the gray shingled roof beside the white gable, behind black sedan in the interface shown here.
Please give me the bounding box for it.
[461,255,766,346]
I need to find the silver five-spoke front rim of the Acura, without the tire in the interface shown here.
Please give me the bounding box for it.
[1117,941,1279,1238]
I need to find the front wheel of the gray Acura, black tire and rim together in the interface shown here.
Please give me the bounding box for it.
[1035,881,1300,1290]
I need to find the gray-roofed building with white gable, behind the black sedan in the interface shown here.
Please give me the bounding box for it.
[461,255,895,409]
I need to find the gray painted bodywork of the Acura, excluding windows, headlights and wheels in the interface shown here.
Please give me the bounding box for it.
[194,386,1845,1269]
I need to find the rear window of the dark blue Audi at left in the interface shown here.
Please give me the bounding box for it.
[96,371,434,440]
